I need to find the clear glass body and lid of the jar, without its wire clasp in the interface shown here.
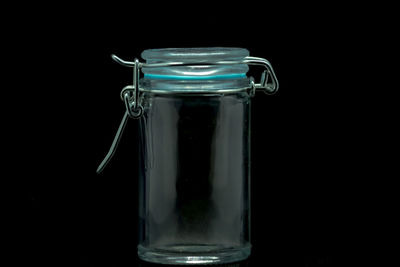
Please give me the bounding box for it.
[138,48,251,264]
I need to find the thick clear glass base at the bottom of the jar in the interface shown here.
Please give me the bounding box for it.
[138,244,251,265]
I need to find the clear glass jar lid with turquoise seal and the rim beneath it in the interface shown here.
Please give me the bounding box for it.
[141,47,249,92]
